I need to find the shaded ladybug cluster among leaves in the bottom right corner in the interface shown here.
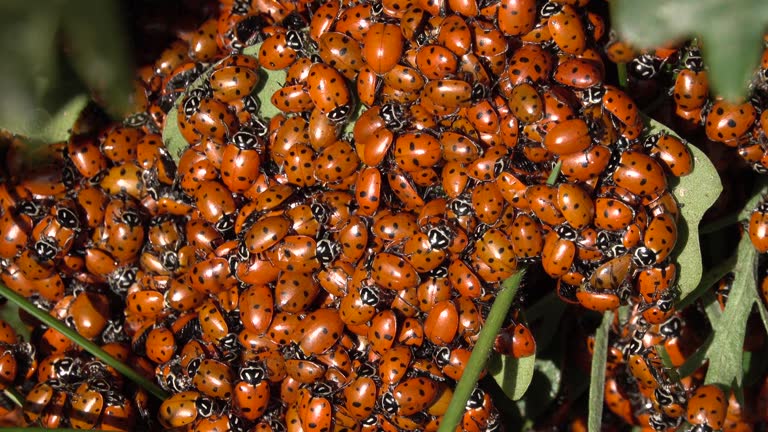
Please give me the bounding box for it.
[570,264,768,432]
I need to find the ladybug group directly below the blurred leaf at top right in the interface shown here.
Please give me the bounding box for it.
[604,35,768,253]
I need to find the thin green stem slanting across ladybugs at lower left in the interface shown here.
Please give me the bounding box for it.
[0,284,168,400]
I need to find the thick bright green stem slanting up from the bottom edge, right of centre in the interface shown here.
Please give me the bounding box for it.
[438,268,525,432]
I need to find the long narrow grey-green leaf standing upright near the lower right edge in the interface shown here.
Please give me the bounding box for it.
[706,236,757,387]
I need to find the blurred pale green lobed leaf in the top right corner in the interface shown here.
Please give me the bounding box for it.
[611,0,768,101]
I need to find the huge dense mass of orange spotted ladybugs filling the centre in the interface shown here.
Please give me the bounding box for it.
[0,0,751,432]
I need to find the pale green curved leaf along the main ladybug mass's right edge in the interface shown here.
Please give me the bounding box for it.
[648,119,723,300]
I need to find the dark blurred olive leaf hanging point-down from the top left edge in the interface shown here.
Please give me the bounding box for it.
[61,0,134,118]
